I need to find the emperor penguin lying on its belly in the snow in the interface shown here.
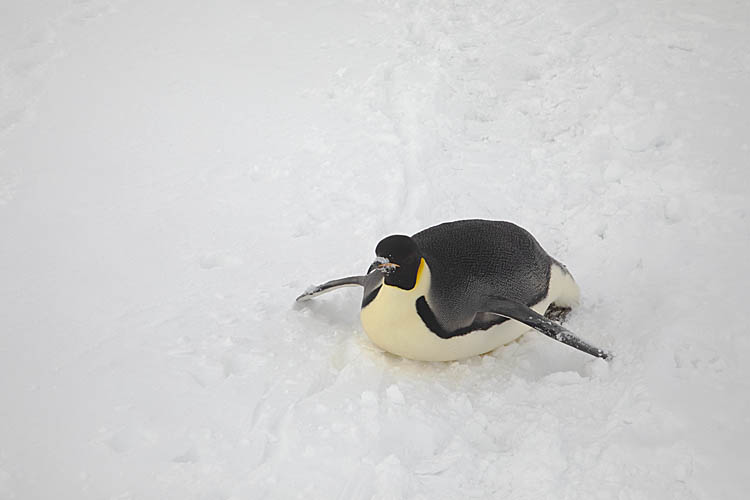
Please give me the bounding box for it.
[297,219,611,361]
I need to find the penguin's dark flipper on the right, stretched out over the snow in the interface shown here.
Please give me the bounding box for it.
[486,297,612,360]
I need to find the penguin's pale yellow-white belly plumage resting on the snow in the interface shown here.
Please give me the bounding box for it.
[360,265,578,361]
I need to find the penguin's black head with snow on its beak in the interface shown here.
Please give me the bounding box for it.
[370,234,422,290]
